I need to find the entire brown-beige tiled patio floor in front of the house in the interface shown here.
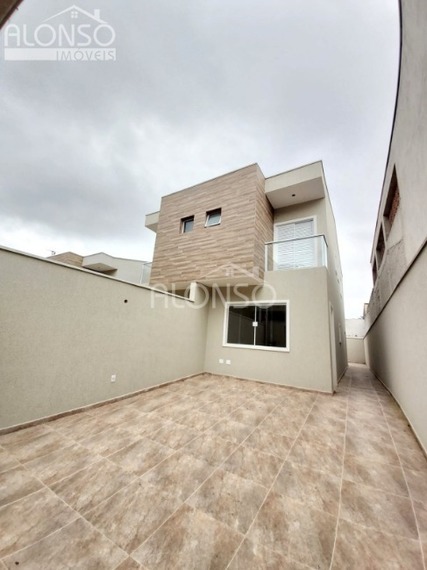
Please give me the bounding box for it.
[0,366,427,570]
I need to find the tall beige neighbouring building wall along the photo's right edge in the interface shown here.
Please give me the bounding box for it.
[366,0,427,449]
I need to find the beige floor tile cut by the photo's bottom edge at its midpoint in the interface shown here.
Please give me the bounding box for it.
[132,505,243,570]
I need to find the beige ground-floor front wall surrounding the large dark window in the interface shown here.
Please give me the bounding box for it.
[205,267,332,392]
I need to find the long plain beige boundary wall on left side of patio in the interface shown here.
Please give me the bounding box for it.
[0,248,206,428]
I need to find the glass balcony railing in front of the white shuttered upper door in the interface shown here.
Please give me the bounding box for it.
[265,235,328,271]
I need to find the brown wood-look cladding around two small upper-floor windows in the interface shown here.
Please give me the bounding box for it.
[150,164,273,288]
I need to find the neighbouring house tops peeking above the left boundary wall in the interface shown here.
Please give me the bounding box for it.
[47,251,151,285]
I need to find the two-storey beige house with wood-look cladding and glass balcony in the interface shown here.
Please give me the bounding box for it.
[146,162,347,392]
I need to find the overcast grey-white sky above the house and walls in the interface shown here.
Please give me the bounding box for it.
[0,0,399,317]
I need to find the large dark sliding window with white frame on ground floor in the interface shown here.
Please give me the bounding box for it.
[224,302,288,350]
